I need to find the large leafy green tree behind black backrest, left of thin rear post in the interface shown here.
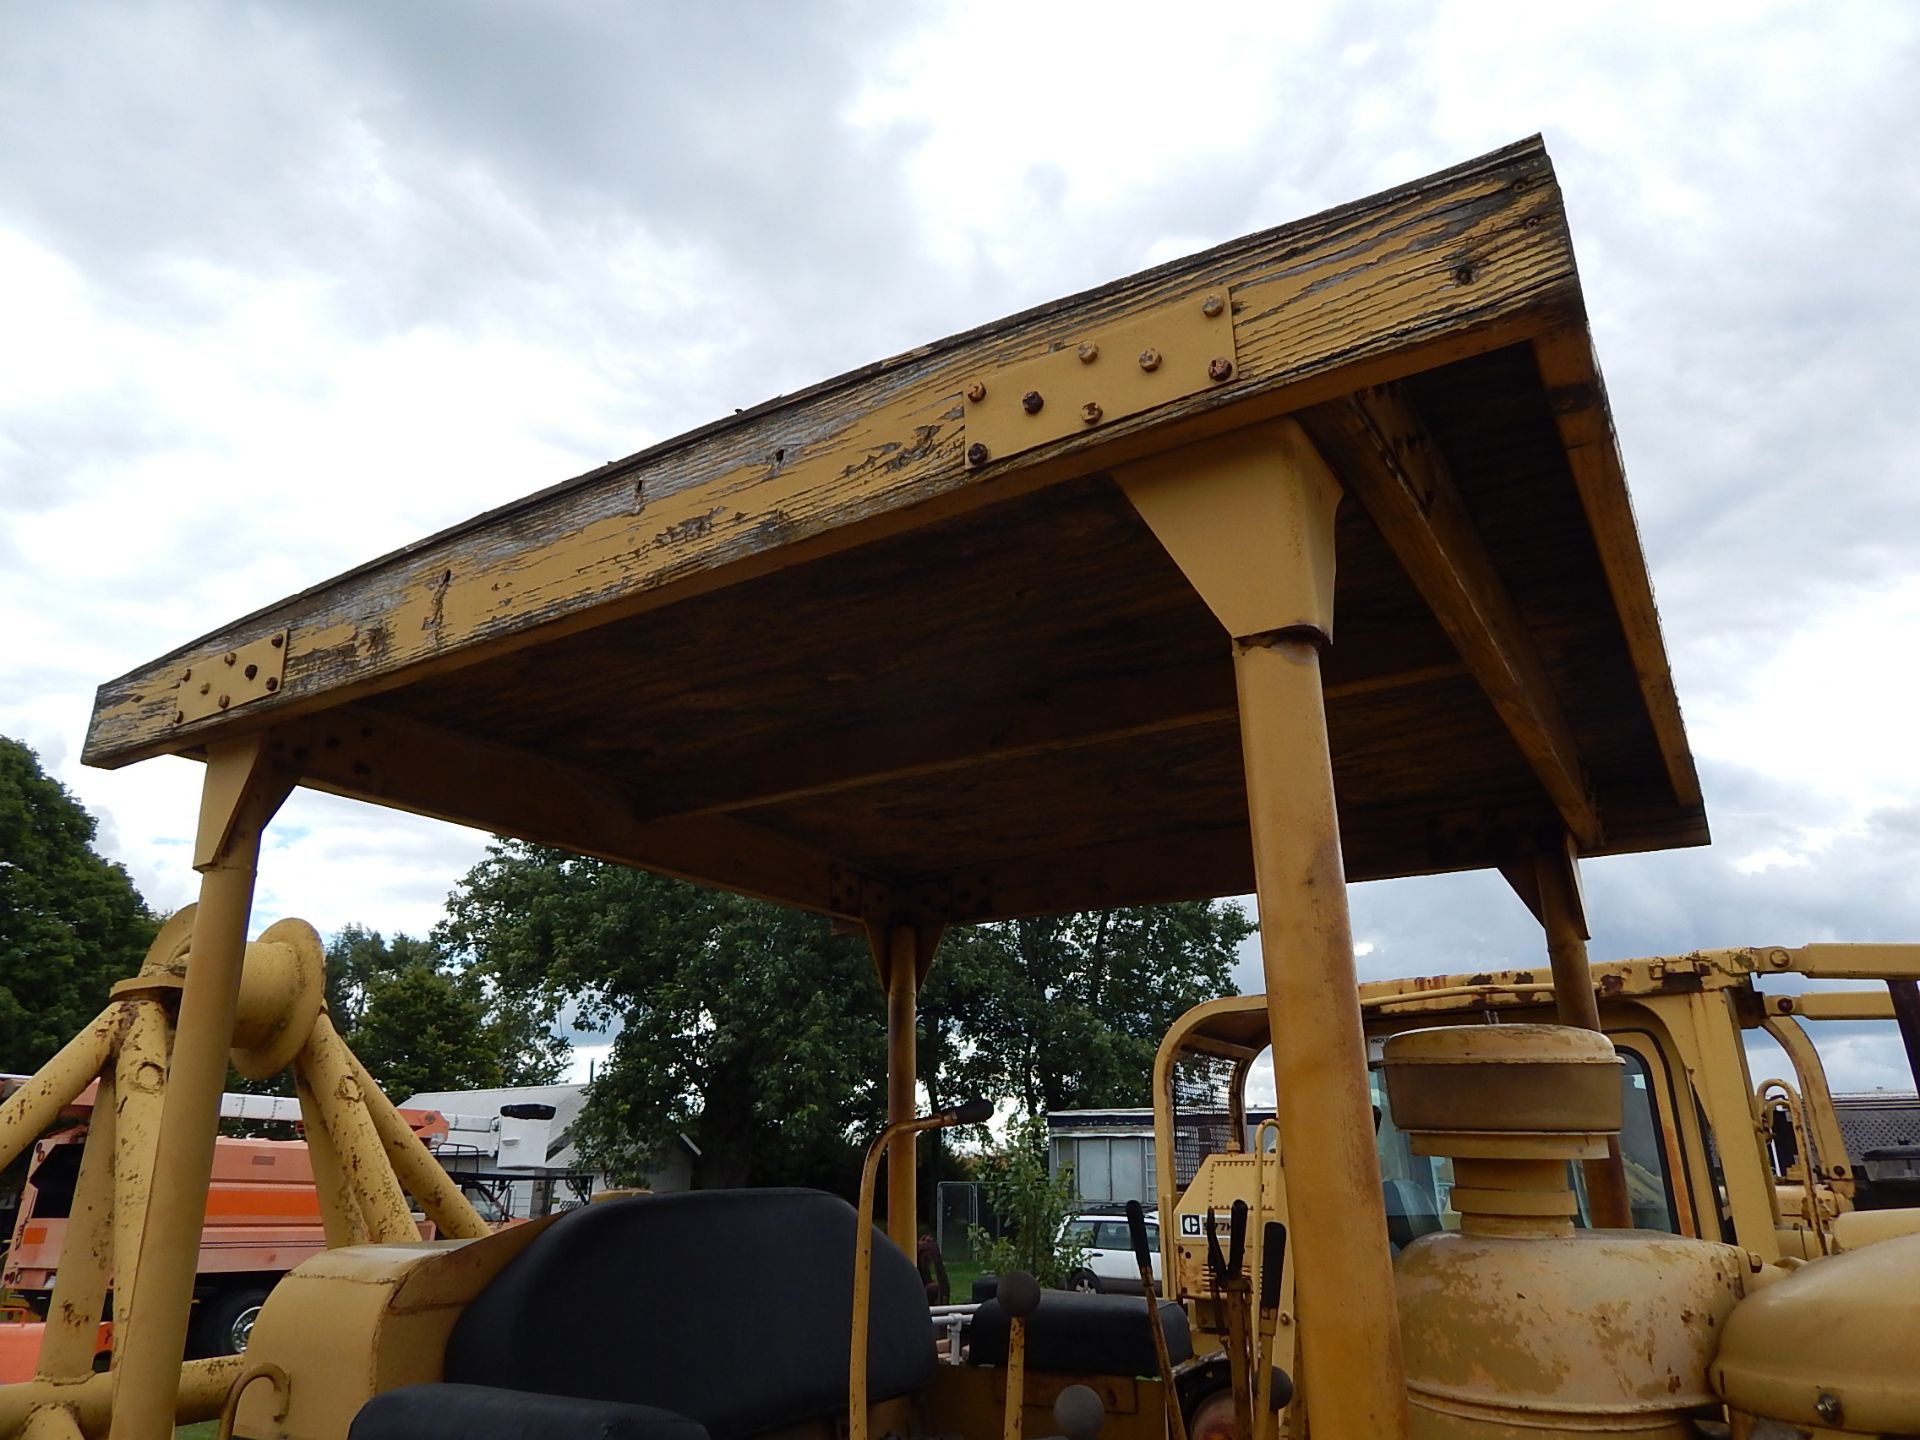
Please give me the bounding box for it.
[436,841,885,1190]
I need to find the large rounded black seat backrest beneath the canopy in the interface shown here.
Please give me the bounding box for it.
[445,1190,935,1440]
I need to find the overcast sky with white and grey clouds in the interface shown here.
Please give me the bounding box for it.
[0,0,1920,1089]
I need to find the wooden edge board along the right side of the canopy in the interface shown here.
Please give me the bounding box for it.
[1534,326,1705,817]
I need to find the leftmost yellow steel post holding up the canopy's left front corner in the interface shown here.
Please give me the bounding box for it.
[111,735,292,1440]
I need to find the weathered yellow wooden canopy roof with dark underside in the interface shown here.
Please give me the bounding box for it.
[84,138,1707,920]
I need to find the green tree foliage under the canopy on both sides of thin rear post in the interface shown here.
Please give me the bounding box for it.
[436,841,1252,1198]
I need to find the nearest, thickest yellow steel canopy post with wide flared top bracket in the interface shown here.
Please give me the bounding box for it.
[1116,420,1407,1440]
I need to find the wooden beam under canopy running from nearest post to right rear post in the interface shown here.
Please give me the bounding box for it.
[1300,386,1601,851]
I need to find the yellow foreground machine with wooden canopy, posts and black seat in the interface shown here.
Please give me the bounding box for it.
[0,140,1920,1440]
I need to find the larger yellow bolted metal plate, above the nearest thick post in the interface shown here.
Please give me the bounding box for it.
[966,286,1238,467]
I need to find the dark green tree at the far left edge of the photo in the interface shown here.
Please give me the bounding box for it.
[0,735,157,1071]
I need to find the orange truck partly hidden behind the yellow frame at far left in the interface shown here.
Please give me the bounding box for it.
[0,1077,447,1382]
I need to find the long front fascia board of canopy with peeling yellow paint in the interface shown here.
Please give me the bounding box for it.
[84,140,1578,766]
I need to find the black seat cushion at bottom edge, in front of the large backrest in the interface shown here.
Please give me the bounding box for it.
[348,1384,708,1440]
